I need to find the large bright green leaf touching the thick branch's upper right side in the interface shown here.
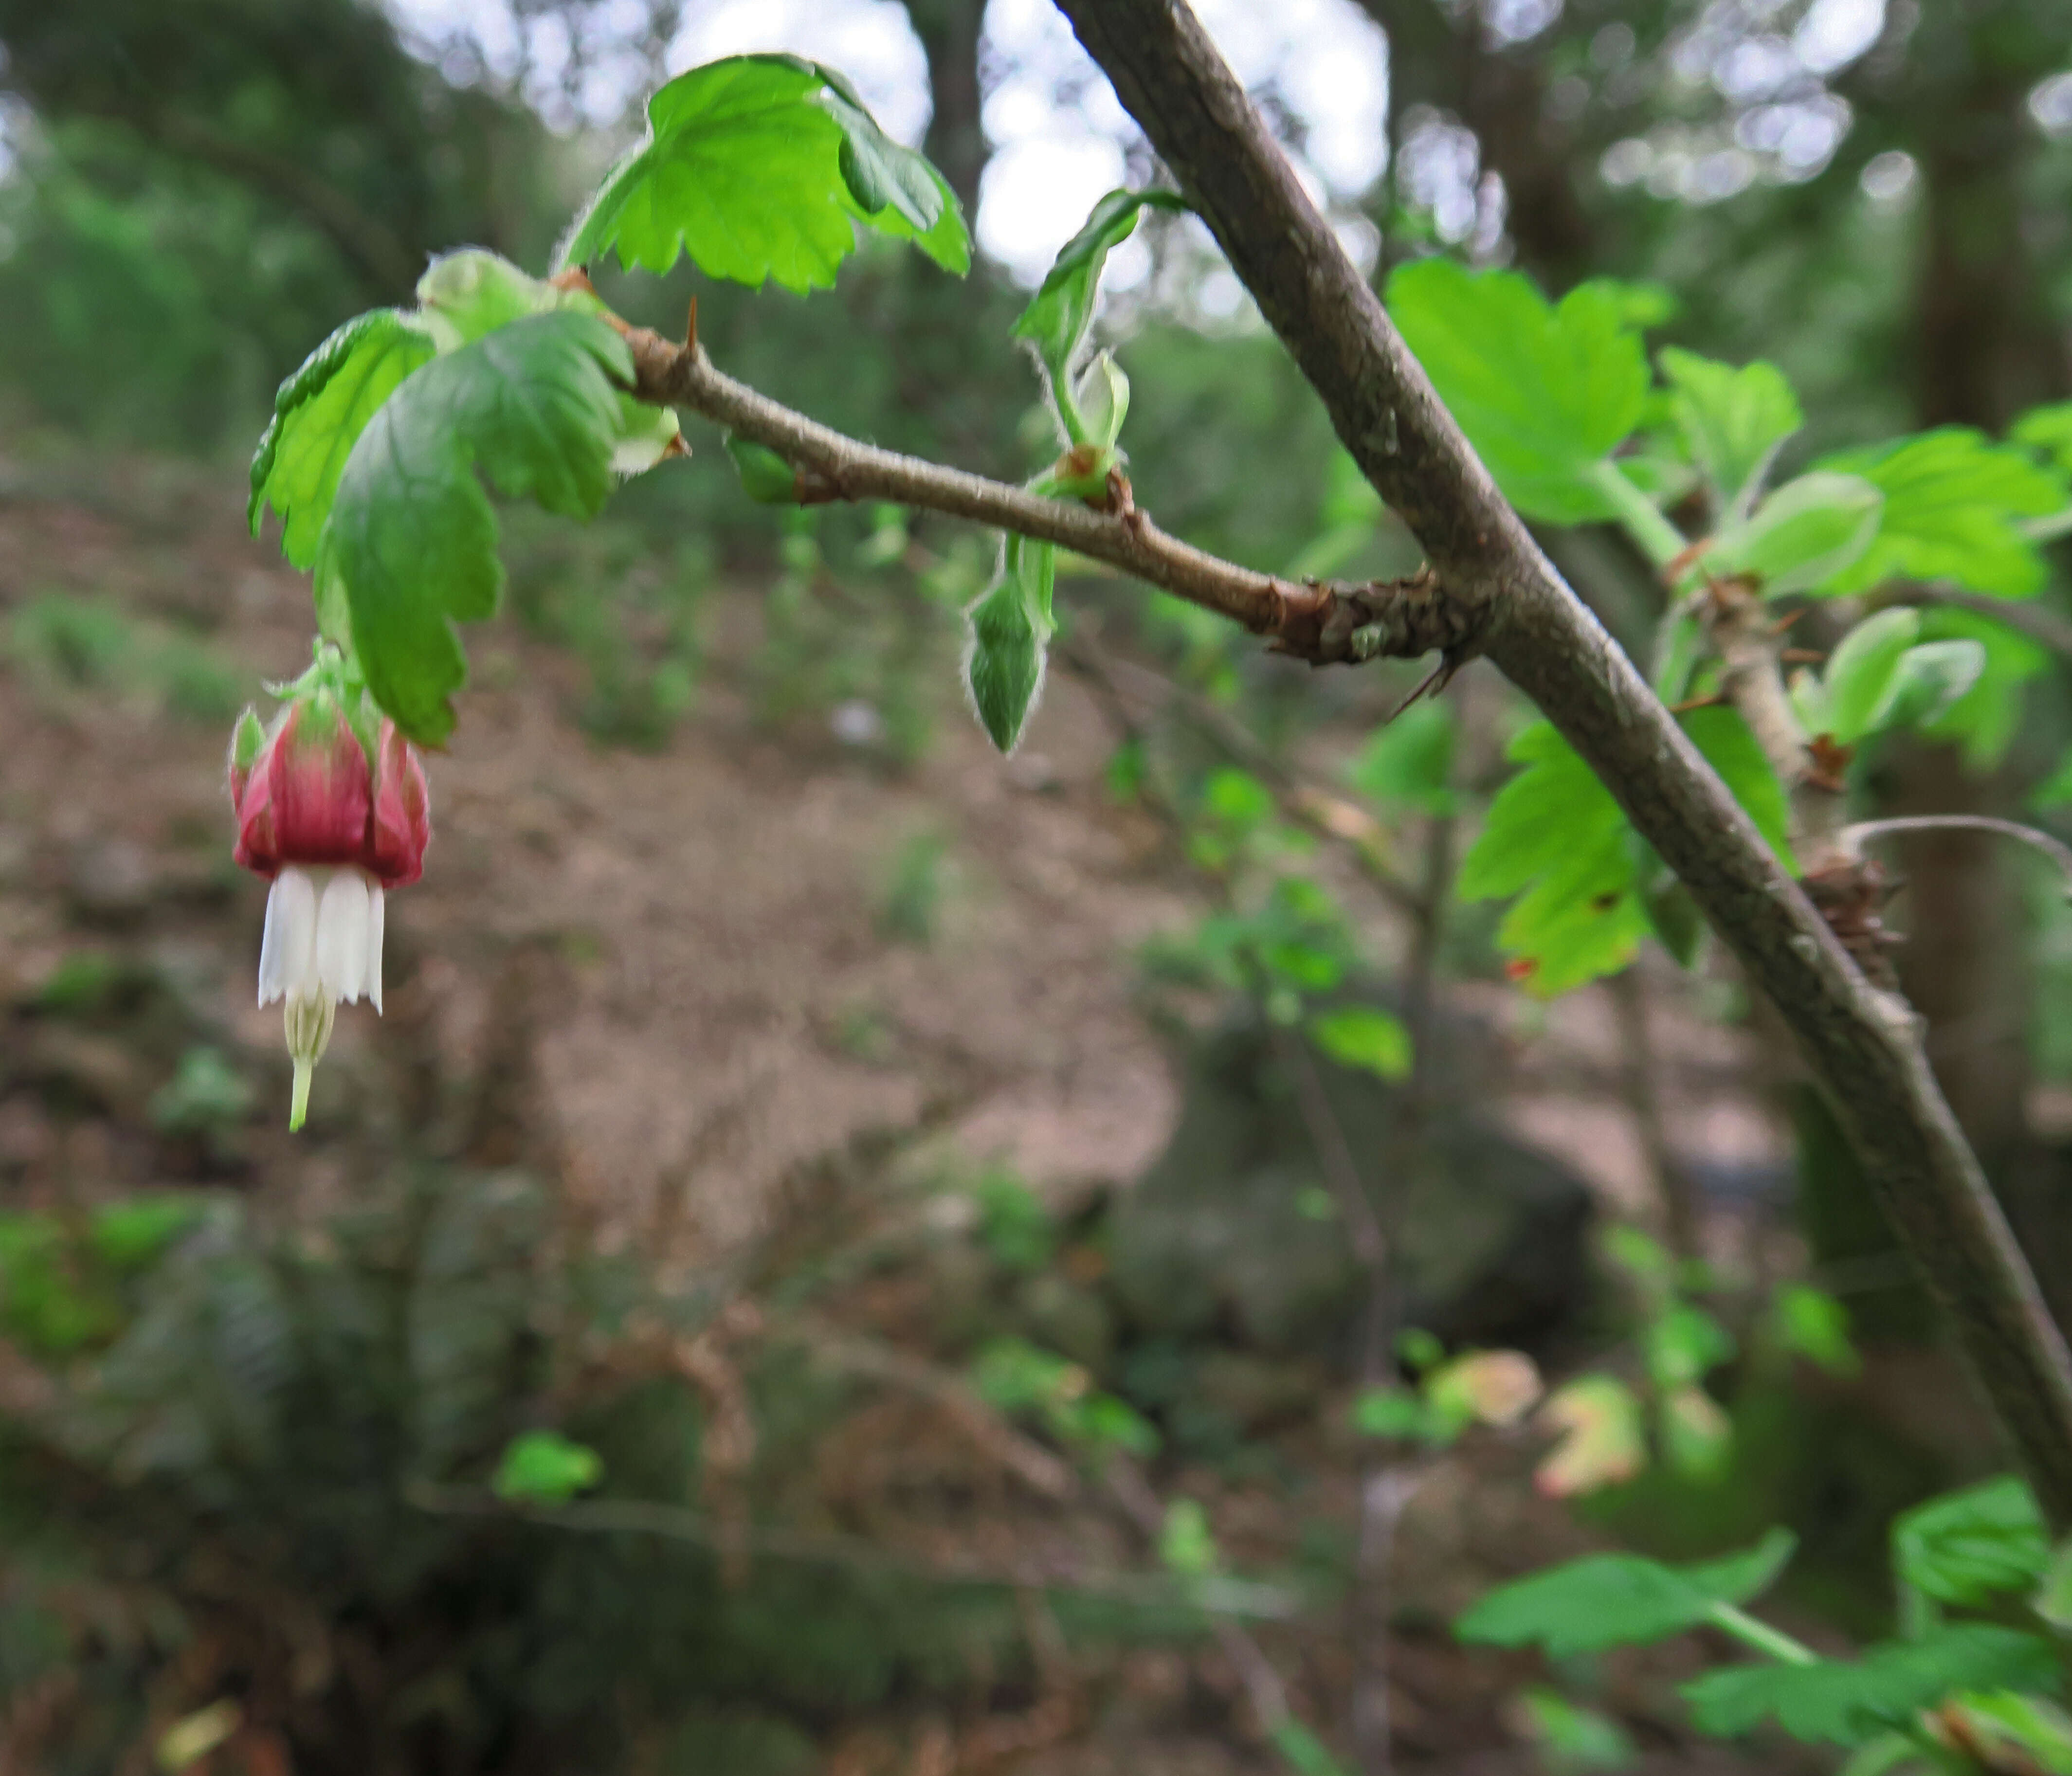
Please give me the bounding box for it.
[1388,259,1647,525]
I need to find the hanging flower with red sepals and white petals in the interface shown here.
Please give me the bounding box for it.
[230,671,431,1129]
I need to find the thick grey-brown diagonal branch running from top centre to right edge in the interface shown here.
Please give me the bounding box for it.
[1059,0,2072,1523]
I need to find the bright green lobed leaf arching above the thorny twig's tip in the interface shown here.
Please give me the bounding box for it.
[560,56,970,294]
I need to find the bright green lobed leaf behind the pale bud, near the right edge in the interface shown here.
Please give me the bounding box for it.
[1819,425,2066,599]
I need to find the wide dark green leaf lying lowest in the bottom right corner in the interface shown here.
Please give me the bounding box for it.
[1682,1623,2057,1745]
